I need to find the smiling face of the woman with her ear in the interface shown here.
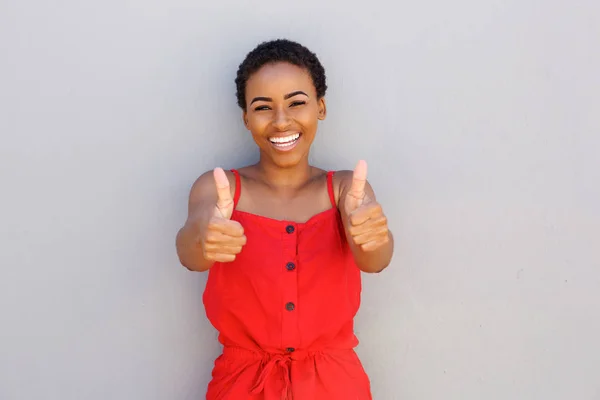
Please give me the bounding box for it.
[243,62,326,167]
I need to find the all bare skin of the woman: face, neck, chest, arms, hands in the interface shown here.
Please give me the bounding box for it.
[177,63,394,272]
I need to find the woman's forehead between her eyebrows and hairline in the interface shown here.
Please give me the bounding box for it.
[246,62,316,100]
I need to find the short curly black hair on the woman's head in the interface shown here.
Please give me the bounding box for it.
[235,39,327,111]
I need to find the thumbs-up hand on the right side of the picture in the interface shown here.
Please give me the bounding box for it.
[344,160,390,252]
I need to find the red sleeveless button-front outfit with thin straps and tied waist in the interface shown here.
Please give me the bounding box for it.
[203,170,371,400]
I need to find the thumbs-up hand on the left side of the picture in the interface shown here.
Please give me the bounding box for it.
[200,168,246,262]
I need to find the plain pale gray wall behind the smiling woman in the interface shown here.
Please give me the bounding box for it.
[0,0,600,400]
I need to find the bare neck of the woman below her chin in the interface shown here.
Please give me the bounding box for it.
[257,156,312,189]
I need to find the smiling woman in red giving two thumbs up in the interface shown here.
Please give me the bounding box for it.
[177,40,393,400]
